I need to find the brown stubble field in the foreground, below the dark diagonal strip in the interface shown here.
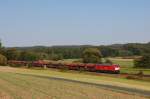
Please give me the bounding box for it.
[0,72,146,99]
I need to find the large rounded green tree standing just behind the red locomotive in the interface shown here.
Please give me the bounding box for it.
[82,48,102,63]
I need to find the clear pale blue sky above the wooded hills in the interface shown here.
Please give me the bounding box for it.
[0,0,150,46]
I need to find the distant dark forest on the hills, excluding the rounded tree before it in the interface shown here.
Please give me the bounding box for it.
[1,42,150,60]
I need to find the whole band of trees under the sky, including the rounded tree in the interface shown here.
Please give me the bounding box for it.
[0,42,150,66]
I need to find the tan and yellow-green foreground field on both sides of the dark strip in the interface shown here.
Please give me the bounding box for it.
[0,66,150,99]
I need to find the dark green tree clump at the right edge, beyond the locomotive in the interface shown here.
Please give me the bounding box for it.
[134,54,150,68]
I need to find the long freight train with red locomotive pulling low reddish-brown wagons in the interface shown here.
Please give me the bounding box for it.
[8,60,120,73]
